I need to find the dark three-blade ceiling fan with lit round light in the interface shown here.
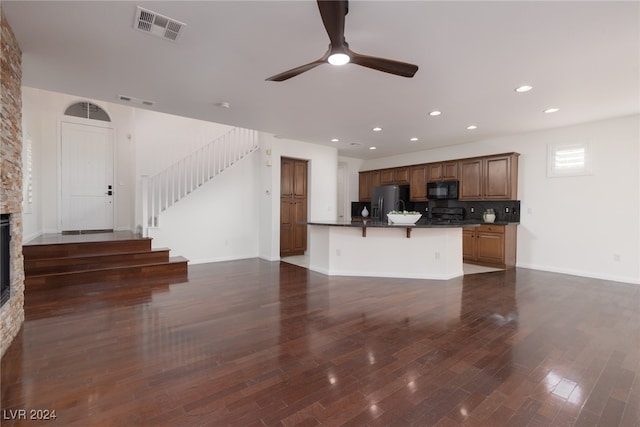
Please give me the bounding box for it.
[266,0,418,82]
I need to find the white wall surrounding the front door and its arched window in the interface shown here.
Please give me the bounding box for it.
[22,86,136,240]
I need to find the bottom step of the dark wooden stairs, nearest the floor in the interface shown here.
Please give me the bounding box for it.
[25,257,188,290]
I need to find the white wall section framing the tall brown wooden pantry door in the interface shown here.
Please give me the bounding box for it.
[260,134,338,260]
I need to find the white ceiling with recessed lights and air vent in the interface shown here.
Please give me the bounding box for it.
[2,0,640,159]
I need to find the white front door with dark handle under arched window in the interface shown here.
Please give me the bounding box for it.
[61,122,114,231]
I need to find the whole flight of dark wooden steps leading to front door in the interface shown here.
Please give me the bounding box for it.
[22,235,188,290]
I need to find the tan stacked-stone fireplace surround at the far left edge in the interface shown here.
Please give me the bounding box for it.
[0,6,24,360]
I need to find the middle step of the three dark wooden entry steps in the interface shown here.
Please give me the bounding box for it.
[24,248,170,277]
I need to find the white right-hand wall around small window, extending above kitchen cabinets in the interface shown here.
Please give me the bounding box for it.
[362,116,640,283]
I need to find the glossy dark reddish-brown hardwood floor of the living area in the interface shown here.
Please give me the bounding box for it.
[1,259,640,427]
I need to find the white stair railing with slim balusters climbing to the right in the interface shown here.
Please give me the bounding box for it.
[141,128,258,236]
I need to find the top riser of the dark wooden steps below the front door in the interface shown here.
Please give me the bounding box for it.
[22,237,151,260]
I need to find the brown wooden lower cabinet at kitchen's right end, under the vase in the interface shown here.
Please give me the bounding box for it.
[462,224,517,268]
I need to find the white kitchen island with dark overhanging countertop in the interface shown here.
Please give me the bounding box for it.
[306,221,469,280]
